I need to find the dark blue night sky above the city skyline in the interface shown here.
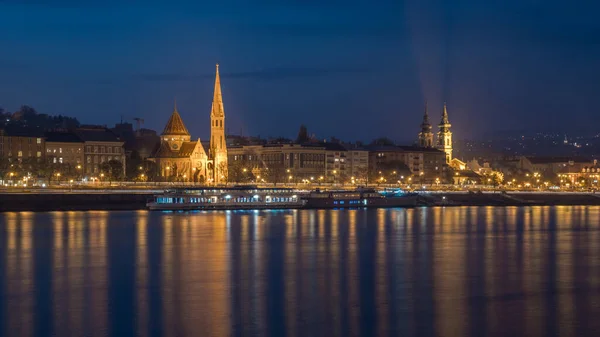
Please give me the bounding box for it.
[0,0,600,141]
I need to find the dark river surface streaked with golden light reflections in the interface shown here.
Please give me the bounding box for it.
[0,207,600,337]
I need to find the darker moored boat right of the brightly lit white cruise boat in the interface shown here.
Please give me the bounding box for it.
[304,188,417,208]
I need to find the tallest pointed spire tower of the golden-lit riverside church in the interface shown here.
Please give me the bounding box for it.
[210,64,227,184]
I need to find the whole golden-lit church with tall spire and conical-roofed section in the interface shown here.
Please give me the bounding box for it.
[149,64,227,184]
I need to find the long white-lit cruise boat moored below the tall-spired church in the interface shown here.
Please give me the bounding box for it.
[147,186,305,211]
